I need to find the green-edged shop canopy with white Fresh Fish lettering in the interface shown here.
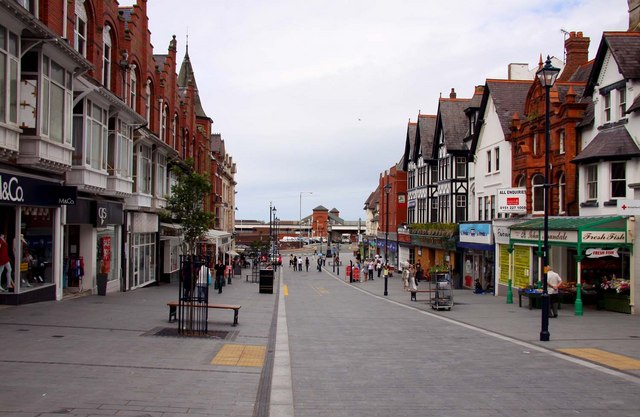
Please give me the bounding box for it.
[509,216,632,251]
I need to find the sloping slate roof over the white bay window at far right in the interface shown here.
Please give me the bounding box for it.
[571,125,640,164]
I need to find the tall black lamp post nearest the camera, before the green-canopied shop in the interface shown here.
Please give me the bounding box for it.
[536,56,560,342]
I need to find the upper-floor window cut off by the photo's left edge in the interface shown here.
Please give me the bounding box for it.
[0,25,19,124]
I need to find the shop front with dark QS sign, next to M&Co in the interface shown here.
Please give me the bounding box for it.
[63,196,124,294]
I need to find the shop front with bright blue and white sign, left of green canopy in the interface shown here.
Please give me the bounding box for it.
[458,222,495,292]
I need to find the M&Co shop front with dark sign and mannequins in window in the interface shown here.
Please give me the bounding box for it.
[0,170,77,305]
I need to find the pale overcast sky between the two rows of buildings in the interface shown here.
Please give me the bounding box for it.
[120,0,628,220]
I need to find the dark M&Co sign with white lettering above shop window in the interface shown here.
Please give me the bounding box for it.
[0,172,78,206]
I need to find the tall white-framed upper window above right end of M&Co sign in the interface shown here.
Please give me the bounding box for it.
[41,56,73,144]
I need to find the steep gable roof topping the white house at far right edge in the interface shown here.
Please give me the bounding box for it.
[585,32,640,96]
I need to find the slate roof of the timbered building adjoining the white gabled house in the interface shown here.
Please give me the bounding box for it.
[436,98,471,155]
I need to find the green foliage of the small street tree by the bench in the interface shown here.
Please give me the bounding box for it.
[166,159,214,254]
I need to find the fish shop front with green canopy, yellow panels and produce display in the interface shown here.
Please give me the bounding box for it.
[508,216,636,315]
